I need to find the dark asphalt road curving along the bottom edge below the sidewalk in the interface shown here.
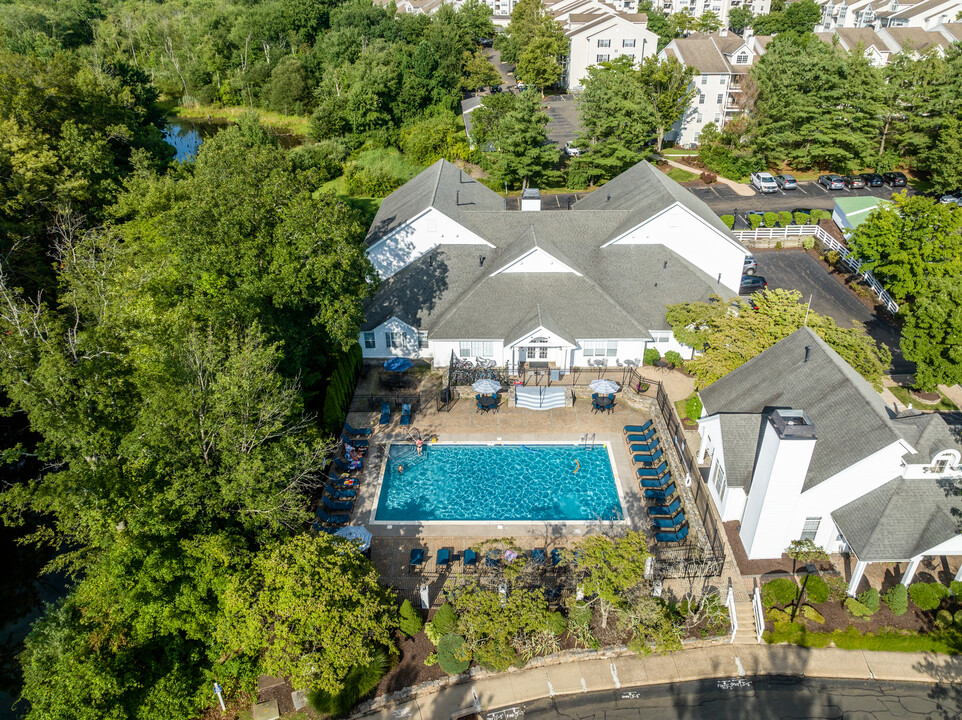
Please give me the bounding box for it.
[483,677,962,720]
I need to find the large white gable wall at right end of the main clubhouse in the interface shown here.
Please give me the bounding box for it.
[609,203,748,296]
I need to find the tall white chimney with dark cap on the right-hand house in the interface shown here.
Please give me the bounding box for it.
[738,409,816,560]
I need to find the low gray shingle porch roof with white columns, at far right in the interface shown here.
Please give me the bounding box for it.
[832,478,962,561]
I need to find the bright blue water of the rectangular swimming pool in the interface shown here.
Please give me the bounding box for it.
[374,444,622,522]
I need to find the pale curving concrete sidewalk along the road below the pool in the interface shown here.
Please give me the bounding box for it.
[354,645,962,720]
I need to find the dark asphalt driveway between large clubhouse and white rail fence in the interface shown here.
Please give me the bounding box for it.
[753,250,915,375]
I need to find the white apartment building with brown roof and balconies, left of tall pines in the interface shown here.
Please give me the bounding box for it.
[659,30,772,147]
